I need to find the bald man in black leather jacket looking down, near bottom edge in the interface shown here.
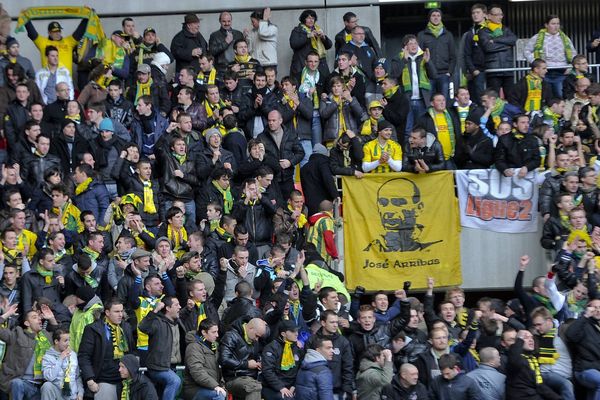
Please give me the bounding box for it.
[219,318,267,400]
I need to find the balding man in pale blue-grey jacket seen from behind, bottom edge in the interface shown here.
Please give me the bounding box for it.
[467,347,506,400]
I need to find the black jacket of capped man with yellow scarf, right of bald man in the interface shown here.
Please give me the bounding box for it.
[261,336,304,392]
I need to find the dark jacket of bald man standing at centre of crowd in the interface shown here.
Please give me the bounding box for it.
[257,129,304,182]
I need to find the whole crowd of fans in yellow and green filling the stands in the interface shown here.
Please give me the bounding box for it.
[0,4,600,400]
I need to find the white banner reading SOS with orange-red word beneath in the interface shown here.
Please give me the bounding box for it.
[455,169,538,233]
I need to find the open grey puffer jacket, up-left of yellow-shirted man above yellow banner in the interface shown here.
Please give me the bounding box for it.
[319,97,367,141]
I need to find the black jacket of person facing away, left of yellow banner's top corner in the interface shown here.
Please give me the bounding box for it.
[300,153,338,216]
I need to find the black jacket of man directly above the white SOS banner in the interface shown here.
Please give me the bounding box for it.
[494,134,541,173]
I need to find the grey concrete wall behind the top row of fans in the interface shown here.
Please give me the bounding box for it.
[4,0,379,81]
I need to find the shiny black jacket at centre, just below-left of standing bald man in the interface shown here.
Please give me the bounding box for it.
[233,196,277,247]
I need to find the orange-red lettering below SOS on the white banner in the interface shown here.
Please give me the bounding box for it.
[465,195,533,221]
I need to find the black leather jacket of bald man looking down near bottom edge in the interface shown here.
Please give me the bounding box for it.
[219,318,261,381]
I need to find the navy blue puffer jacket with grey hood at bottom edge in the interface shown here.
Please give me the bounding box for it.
[295,349,333,400]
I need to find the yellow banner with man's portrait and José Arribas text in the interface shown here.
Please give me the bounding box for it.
[342,171,462,290]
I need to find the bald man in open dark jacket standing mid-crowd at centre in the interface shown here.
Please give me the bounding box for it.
[257,110,304,200]
